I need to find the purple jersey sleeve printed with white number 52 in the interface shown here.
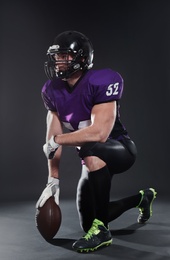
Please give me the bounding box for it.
[91,69,123,104]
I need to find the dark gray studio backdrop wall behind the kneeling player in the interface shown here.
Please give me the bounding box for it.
[0,0,170,201]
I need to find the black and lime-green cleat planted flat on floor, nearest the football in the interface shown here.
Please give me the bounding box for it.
[72,219,112,253]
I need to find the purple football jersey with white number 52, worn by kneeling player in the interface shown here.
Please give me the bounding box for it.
[42,69,125,137]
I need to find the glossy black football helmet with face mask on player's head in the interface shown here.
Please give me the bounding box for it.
[44,31,94,80]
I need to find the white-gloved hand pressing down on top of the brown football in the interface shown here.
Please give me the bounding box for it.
[36,177,60,209]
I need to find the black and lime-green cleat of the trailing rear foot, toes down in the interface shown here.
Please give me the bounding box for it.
[137,188,157,224]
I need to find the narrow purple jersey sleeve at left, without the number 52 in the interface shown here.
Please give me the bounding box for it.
[41,81,56,111]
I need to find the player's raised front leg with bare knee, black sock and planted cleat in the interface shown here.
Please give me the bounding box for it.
[73,136,134,252]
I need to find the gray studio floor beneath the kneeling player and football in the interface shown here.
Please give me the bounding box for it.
[0,199,170,260]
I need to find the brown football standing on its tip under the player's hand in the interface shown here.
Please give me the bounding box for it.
[35,196,62,240]
